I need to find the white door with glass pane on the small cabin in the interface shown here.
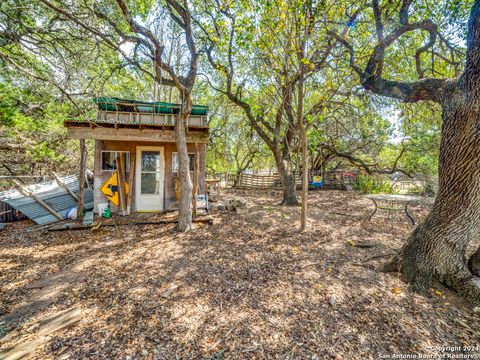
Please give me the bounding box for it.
[135,146,165,211]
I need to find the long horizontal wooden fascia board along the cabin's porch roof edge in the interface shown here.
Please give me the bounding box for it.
[67,126,208,144]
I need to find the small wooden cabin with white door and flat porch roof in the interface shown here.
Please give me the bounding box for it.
[65,98,208,212]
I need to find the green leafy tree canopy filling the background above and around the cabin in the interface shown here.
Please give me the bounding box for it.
[0,0,473,186]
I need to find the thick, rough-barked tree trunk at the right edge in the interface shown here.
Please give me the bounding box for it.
[387,87,480,303]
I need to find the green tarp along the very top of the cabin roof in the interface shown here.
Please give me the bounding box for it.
[93,97,208,115]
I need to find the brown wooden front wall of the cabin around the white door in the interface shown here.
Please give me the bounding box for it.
[94,140,206,212]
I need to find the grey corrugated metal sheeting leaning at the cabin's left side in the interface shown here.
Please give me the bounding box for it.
[0,175,93,225]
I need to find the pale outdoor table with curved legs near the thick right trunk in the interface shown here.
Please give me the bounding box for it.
[365,194,434,225]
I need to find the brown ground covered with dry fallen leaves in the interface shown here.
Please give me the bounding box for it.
[0,191,480,359]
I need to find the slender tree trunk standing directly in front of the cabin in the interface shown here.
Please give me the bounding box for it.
[175,92,192,232]
